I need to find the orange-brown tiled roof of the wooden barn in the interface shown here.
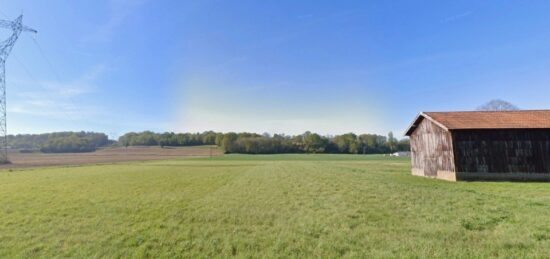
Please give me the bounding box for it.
[405,110,550,136]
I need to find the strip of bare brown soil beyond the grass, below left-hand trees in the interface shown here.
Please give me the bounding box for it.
[0,146,223,169]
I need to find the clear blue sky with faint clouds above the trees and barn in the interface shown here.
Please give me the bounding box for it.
[0,0,550,137]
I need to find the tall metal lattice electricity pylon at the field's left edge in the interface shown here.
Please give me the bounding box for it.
[0,15,37,164]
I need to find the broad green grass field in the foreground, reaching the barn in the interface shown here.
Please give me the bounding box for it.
[0,155,550,258]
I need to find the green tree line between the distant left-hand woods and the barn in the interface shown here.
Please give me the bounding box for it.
[118,131,410,154]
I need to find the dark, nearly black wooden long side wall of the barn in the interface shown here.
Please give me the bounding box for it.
[452,129,550,180]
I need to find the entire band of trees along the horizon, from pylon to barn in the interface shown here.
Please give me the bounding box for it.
[8,131,410,154]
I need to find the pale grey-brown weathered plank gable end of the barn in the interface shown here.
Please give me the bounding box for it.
[410,119,455,180]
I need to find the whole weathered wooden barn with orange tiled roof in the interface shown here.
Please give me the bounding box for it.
[405,110,550,181]
